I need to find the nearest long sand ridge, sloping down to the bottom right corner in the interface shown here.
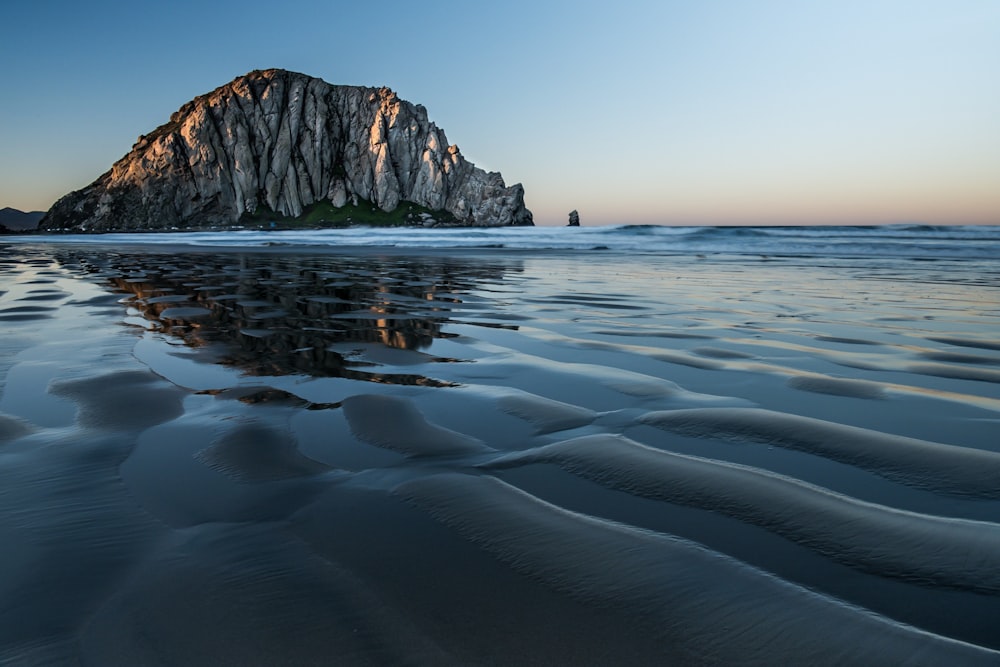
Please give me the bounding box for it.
[395,475,1000,665]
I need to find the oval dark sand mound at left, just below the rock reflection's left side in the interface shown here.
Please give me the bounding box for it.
[50,371,187,431]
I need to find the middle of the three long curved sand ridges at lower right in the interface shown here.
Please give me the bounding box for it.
[487,435,1000,593]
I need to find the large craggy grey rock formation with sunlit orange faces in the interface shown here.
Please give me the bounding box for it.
[40,70,532,231]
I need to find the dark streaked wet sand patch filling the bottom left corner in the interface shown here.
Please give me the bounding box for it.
[0,432,163,665]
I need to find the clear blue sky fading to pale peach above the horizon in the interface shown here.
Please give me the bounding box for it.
[0,0,1000,225]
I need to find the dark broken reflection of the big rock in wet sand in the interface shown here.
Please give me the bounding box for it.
[77,250,509,386]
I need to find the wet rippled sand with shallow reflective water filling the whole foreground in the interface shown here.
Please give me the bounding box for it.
[0,243,1000,665]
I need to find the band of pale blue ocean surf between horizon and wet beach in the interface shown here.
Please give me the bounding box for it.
[19,225,1000,259]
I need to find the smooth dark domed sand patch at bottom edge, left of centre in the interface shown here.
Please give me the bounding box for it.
[80,524,457,667]
